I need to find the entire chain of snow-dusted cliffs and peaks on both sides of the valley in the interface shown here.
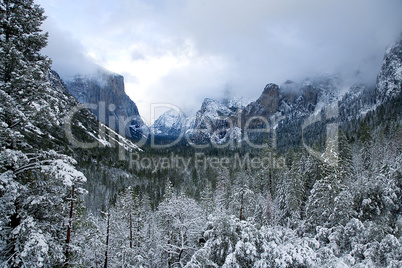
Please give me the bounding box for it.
[66,34,402,150]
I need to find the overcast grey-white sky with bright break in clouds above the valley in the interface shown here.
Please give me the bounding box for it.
[36,0,402,123]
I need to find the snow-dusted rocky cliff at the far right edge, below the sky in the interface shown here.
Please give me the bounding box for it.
[376,35,402,104]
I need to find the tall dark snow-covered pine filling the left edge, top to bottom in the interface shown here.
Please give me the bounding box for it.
[0,0,93,267]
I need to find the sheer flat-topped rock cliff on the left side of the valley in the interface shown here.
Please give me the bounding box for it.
[66,69,147,139]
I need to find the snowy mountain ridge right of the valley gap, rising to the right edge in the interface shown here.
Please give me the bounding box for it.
[150,33,402,148]
